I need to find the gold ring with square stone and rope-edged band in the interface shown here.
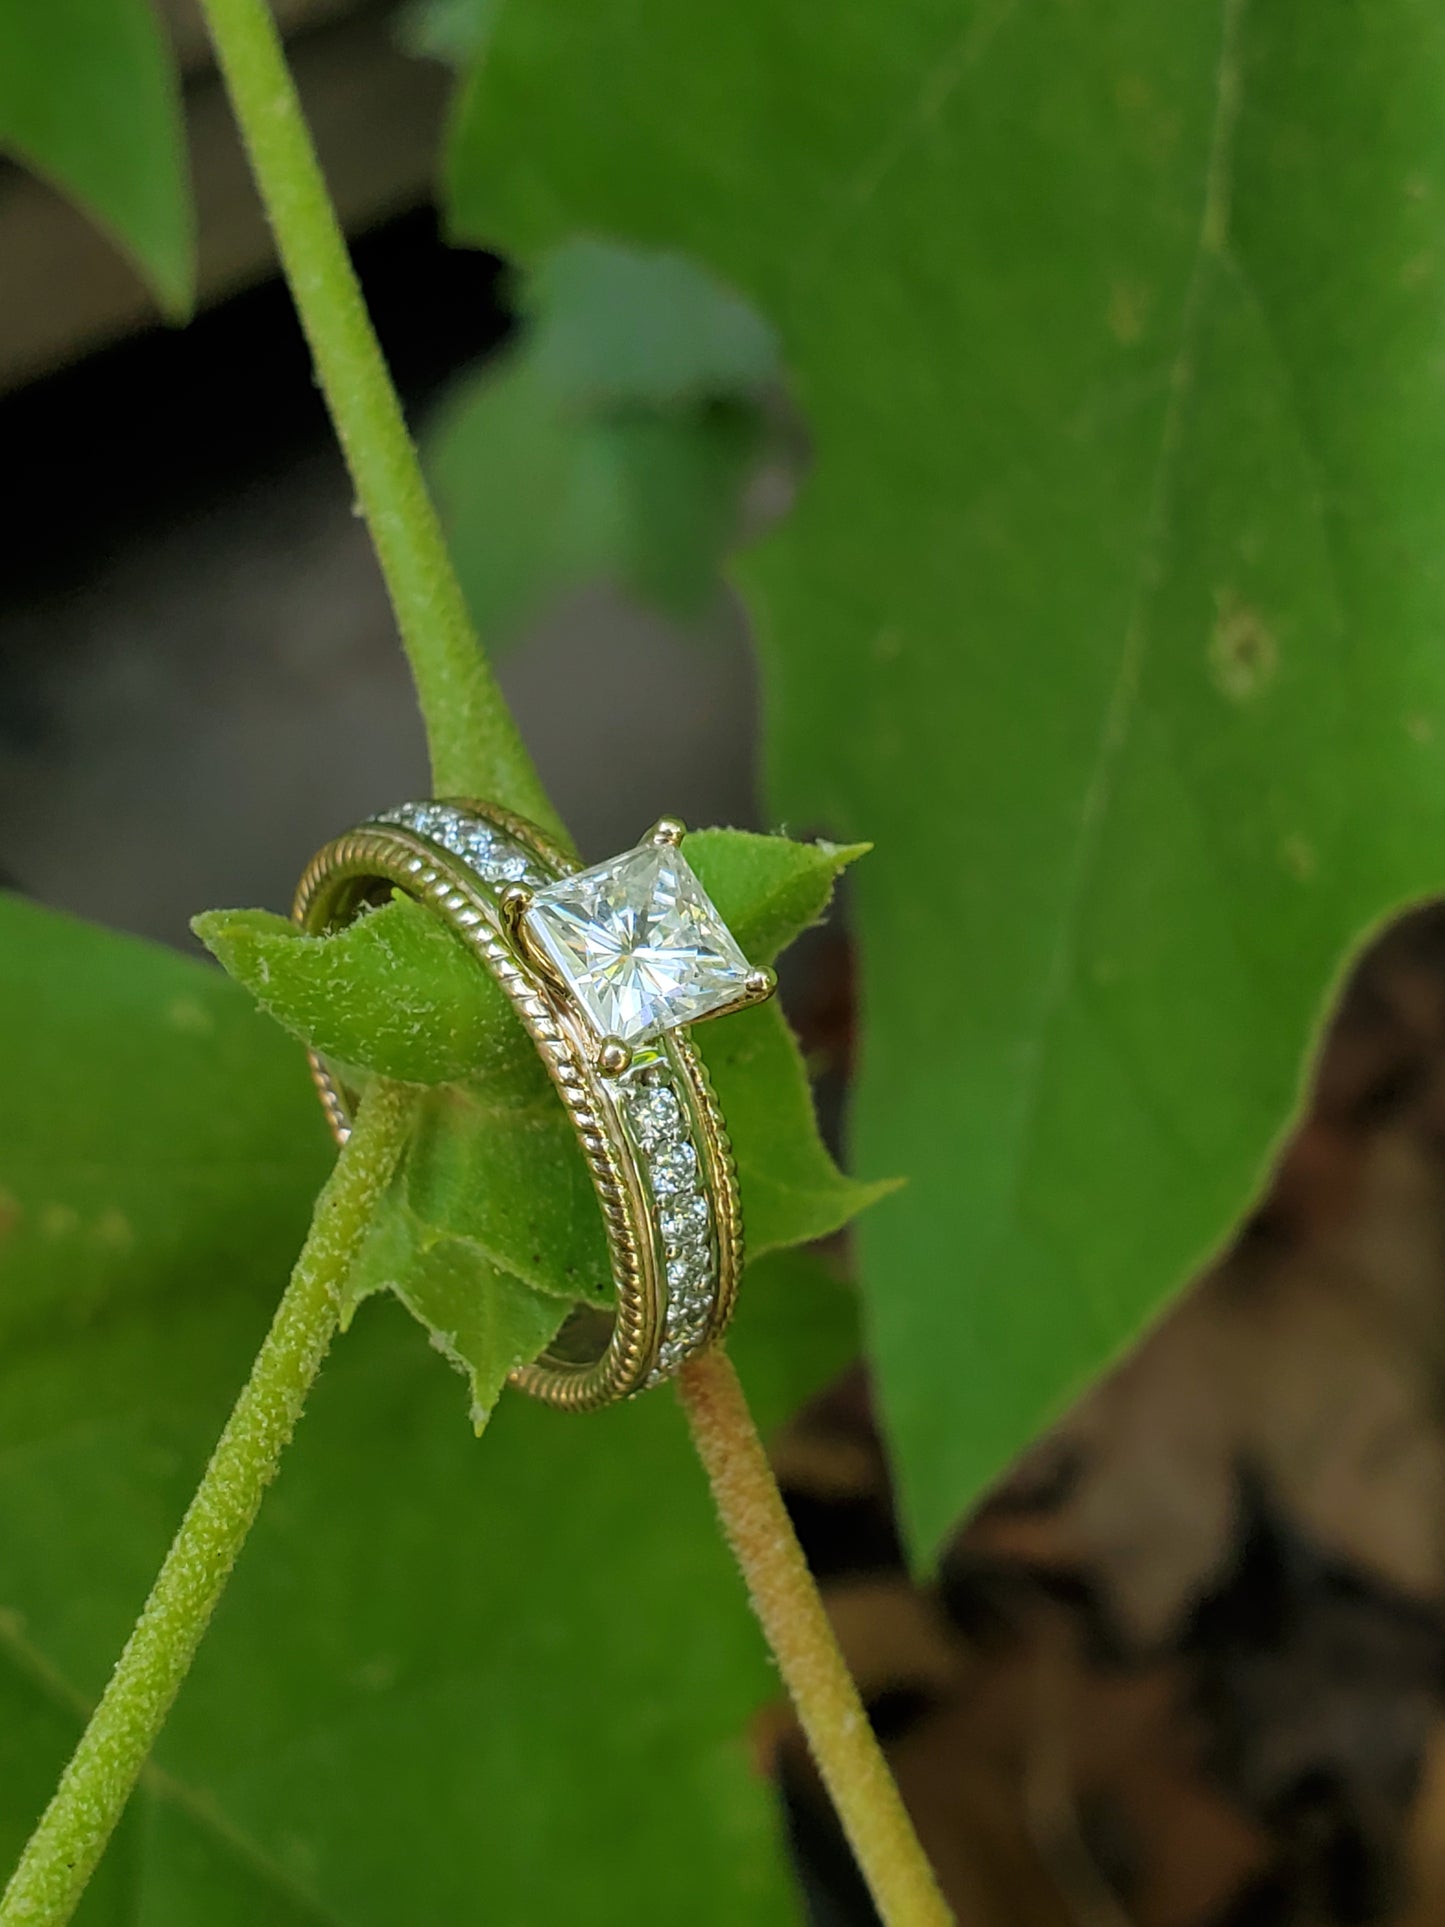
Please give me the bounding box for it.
[293,802,776,1411]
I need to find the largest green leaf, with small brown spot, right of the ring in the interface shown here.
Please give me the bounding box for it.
[451,0,1445,1540]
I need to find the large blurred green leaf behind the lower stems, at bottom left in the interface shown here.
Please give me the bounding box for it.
[0,900,850,1927]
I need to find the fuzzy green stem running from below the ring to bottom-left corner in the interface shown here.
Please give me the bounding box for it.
[0,1081,412,1927]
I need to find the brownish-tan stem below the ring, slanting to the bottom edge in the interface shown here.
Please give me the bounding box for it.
[678,1349,954,1927]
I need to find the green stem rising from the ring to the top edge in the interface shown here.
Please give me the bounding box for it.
[187,0,563,831]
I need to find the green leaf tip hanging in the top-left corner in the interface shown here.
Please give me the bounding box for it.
[0,0,195,320]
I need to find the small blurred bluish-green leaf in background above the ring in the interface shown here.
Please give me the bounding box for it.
[428,241,776,644]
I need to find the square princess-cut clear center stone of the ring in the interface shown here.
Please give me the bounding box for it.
[522,844,749,1044]
